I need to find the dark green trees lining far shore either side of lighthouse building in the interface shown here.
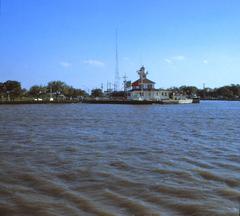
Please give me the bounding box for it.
[0,80,240,101]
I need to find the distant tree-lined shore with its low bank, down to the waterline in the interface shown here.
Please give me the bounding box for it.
[0,80,240,105]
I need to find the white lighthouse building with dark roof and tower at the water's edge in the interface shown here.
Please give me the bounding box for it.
[127,66,170,101]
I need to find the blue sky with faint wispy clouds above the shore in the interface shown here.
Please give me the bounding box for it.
[0,0,240,90]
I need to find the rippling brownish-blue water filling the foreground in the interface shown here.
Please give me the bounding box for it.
[0,102,240,216]
